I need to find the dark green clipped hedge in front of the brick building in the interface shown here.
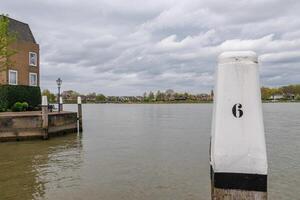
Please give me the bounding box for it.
[0,85,41,111]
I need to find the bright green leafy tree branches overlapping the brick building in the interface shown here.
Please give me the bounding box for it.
[0,14,17,71]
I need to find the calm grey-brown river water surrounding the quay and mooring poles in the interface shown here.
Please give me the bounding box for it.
[0,103,300,200]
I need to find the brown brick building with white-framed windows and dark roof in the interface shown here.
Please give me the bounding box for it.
[0,16,40,86]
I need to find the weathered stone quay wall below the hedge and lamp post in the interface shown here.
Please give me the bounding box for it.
[0,112,77,142]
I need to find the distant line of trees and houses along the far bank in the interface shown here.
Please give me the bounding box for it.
[42,84,300,103]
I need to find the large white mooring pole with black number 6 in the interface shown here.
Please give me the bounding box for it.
[210,51,268,200]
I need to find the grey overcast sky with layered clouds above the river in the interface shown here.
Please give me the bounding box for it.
[0,0,300,95]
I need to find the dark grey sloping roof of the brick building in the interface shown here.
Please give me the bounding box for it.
[9,18,36,43]
